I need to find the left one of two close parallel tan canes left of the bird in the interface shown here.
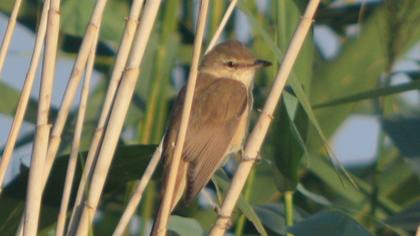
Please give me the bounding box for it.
[69,0,144,229]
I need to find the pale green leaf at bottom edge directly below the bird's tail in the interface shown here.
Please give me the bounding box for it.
[168,215,205,236]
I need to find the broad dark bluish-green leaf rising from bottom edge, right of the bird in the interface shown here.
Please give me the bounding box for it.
[289,210,371,236]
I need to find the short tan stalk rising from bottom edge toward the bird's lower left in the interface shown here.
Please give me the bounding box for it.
[112,140,163,236]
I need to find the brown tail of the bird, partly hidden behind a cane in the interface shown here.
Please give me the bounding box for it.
[150,160,188,236]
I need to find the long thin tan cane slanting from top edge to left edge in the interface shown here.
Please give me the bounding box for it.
[0,0,50,195]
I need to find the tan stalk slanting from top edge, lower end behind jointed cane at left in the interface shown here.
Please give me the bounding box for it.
[39,0,107,188]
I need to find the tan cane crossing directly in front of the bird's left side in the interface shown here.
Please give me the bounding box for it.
[157,0,209,235]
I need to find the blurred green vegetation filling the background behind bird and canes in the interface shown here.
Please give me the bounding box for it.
[0,0,420,235]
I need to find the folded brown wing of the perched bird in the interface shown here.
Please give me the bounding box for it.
[164,74,248,205]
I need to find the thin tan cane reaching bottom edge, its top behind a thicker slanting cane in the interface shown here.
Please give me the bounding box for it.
[55,35,99,236]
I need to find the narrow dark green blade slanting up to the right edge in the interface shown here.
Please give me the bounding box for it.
[312,80,420,109]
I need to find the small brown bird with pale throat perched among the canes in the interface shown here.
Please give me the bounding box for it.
[151,41,271,235]
